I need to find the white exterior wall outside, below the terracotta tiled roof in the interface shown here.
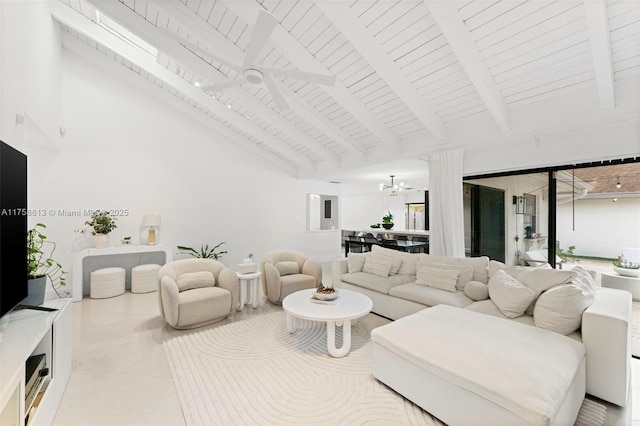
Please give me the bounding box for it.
[557,197,640,259]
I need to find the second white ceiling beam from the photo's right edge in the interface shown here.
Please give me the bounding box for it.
[424,0,510,132]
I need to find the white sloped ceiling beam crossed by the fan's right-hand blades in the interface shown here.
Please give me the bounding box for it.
[224,0,401,151]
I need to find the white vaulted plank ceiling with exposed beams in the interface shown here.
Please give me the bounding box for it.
[54,0,640,190]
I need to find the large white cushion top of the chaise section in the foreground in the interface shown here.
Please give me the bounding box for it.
[371,305,585,425]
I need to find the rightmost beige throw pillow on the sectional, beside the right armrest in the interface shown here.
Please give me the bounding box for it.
[533,283,595,335]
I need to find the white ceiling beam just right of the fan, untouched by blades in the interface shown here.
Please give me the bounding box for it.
[315,0,447,139]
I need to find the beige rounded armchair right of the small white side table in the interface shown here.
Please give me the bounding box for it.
[261,250,322,305]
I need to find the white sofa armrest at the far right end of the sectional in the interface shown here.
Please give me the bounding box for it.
[582,288,632,407]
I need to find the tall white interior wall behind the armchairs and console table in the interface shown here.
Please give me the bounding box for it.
[0,2,341,300]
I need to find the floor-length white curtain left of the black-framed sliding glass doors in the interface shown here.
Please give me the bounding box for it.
[429,149,464,257]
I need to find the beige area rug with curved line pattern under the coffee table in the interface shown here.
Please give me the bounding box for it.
[164,312,606,426]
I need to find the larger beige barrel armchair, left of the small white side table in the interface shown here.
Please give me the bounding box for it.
[158,259,240,329]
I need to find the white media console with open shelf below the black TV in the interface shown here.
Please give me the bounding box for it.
[0,299,72,426]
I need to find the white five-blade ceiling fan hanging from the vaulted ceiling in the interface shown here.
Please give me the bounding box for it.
[163,9,336,111]
